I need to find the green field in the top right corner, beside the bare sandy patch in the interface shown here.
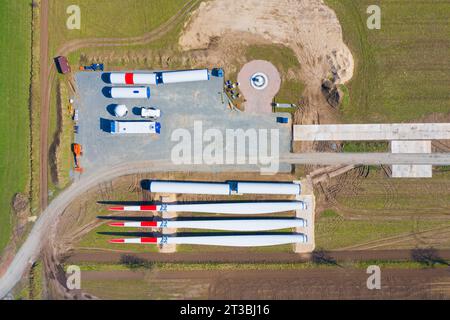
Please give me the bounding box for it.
[325,0,450,122]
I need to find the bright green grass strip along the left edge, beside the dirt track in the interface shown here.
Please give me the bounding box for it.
[0,0,31,252]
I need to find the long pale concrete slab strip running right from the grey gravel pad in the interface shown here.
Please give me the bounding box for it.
[294,123,450,141]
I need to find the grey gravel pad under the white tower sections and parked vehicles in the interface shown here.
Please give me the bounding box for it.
[75,72,292,175]
